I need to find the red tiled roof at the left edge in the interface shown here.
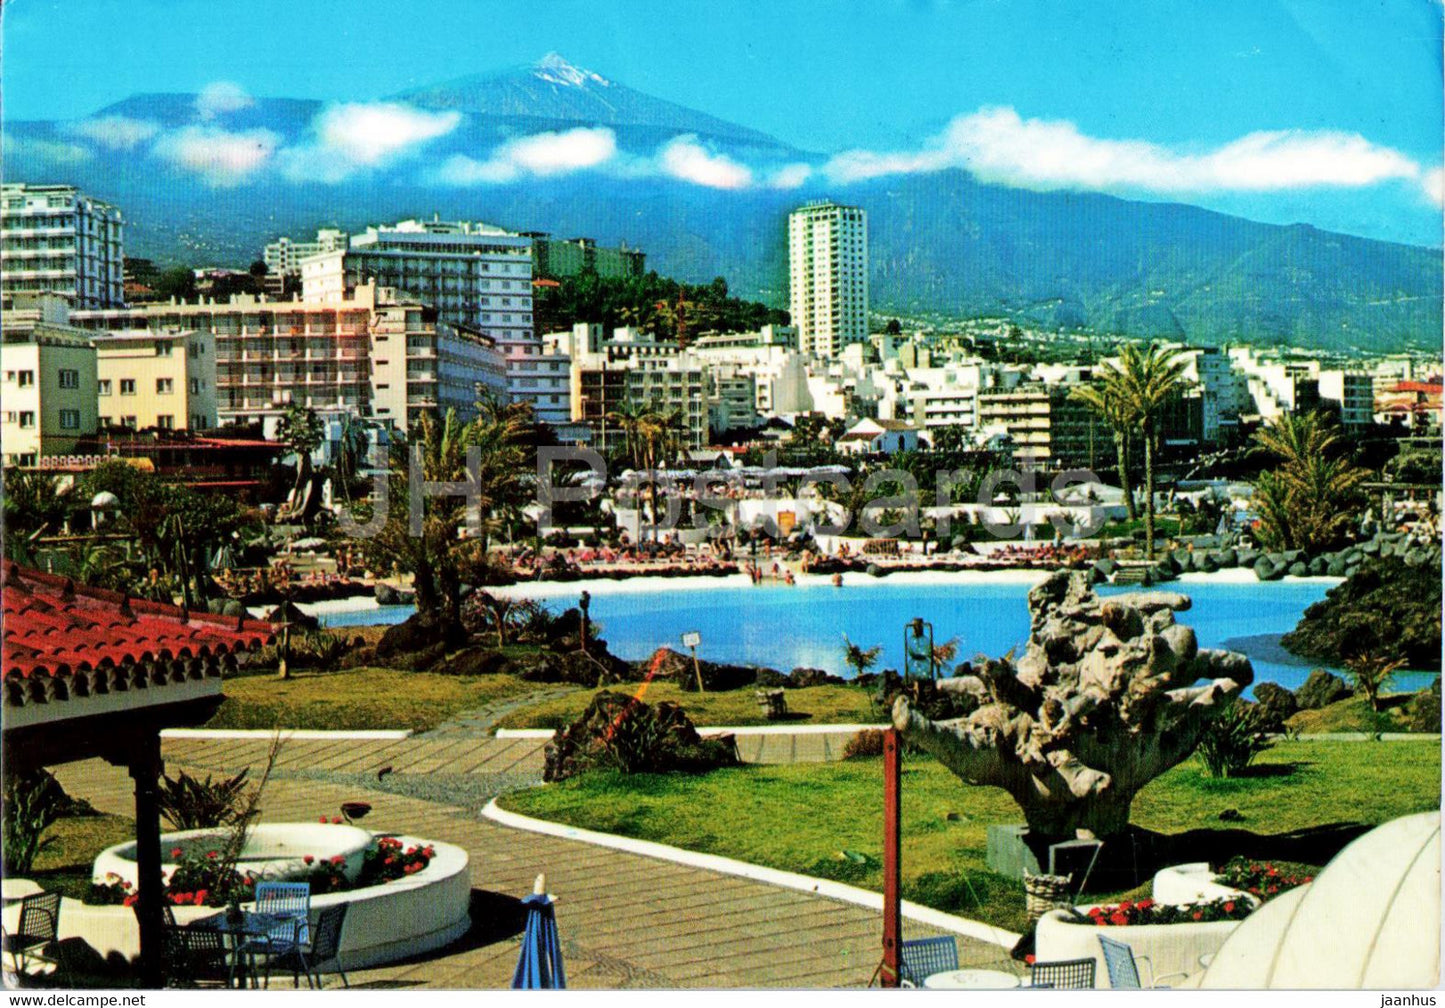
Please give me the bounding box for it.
[0,560,275,679]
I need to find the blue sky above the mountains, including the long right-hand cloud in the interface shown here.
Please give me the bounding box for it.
[3,0,1442,246]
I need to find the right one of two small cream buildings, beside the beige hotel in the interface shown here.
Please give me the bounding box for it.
[90,329,218,430]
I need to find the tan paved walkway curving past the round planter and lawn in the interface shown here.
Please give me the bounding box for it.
[58,738,1017,988]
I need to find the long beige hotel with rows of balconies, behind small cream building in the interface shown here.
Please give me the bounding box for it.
[72,284,507,435]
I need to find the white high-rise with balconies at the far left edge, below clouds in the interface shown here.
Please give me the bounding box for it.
[0,182,126,308]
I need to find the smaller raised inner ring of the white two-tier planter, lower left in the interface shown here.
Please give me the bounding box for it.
[91,823,371,885]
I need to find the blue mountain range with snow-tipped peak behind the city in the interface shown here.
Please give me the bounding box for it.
[4,55,1442,351]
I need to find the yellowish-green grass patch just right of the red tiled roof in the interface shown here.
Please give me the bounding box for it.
[207,669,546,731]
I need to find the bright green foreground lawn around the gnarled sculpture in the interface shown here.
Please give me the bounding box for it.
[503,741,1441,930]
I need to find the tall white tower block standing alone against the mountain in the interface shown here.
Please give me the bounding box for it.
[788,201,868,358]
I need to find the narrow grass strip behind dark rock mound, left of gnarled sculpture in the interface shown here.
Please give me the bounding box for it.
[499,682,884,728]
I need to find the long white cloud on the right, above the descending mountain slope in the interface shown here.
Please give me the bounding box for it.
[824,108,1420,194]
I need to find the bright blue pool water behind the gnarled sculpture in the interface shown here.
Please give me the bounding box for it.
[327,579,1435,690]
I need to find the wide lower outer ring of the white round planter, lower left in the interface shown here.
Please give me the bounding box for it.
[59,823,471,970]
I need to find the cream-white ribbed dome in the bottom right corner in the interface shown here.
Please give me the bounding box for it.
[1199,812,1441,989]
